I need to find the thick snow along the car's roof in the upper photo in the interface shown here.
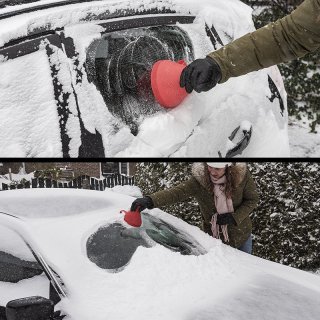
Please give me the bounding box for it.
[0,0,253,47]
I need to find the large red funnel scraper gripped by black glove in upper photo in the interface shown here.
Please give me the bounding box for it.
[151,60,188,108]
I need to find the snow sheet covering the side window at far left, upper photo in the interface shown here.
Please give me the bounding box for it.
[0,50,62,157]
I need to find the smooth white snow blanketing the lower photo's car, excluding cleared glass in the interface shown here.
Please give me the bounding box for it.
[0,189,320,320]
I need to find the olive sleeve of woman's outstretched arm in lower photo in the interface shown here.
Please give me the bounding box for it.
[148,177,198,208]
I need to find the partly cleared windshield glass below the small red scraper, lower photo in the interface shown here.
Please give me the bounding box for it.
[86,213,206,272]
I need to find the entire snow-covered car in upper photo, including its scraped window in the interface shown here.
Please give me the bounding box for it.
[0,0,289,157]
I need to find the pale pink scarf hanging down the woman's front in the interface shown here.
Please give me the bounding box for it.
[210,175,234,242]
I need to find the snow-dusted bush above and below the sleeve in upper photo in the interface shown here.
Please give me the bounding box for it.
[242,0,320,132]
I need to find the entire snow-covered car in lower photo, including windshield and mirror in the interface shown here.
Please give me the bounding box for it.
[0,189,320,320]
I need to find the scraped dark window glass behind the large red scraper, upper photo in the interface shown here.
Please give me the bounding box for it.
[86,26,194,133]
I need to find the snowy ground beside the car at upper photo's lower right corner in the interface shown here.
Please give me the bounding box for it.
[288,119,320,158]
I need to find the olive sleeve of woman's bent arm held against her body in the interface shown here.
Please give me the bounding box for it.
[233,171,259,225]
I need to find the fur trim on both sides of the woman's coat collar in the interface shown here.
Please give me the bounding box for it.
[192,162,247,190]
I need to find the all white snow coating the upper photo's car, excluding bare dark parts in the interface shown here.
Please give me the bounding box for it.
[0,0,290,157]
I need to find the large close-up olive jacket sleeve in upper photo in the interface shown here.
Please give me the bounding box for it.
[208,0,320,83]
